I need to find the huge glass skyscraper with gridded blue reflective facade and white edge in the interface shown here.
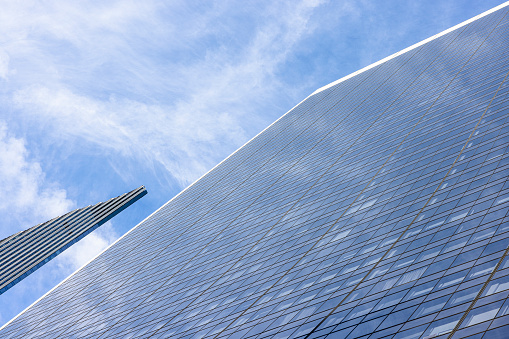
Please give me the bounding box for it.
[0,5,509,339]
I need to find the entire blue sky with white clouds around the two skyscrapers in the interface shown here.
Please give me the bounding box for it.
[0,0,503,326]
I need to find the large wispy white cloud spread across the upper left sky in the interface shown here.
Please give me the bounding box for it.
[0,1,328,186]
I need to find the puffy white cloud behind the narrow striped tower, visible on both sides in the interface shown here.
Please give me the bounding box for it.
[0,121,118,274]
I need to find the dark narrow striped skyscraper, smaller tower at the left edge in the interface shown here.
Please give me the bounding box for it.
[0,186,147,294]
